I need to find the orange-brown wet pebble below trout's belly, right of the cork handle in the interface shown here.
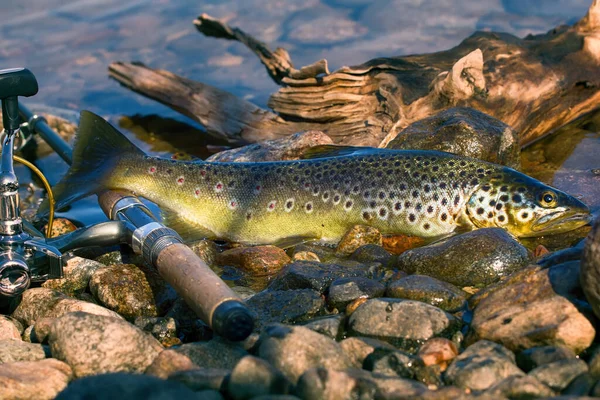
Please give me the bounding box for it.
[217,246,291,276]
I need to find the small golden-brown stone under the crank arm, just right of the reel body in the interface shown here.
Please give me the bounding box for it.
[42,257,106,296]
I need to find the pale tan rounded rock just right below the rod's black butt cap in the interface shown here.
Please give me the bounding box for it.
[258,325,352,384]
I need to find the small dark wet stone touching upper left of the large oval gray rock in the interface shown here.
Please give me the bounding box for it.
[327,277,385,311]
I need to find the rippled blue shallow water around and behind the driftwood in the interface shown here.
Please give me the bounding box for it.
[0,0,600,234]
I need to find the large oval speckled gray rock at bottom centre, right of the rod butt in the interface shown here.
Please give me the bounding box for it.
[348,298,461,353]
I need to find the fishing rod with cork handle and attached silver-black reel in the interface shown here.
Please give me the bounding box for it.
[0,68,254,341]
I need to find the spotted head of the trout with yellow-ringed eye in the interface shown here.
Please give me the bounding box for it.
[466,168,592,237]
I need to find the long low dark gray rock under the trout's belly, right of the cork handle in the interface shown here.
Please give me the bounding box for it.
[269,261,383,294]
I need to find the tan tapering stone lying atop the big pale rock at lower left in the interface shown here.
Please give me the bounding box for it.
[12,288,122,326]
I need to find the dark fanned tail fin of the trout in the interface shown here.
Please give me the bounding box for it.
[38,111,144,216]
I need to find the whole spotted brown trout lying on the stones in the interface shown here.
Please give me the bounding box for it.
[42,111,590,245]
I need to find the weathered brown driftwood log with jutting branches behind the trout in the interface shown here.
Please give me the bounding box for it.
[109,0,600,147]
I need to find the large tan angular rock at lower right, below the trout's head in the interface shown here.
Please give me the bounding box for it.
[467,262,595,354]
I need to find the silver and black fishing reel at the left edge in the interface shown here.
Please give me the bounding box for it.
[0,68,64,297]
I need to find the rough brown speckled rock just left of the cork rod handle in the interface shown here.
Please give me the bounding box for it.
[90,264,177,321]
